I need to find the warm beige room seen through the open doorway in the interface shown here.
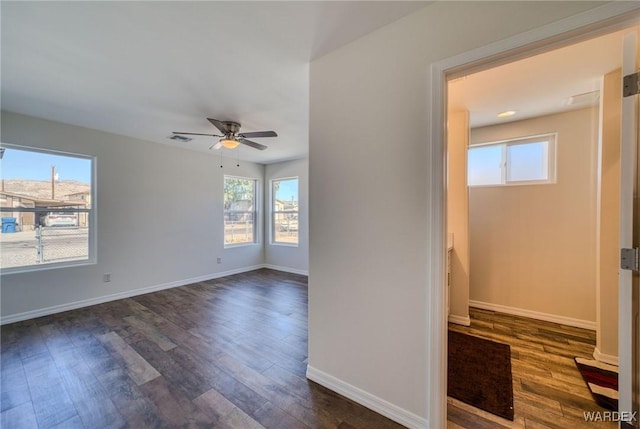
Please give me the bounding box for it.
[448,28,637,426]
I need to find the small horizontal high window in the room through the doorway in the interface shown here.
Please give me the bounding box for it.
[467,134,556,186]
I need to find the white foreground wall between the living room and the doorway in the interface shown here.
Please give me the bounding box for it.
[308,2,598,427]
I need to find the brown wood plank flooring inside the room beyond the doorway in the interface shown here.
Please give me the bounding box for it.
[448,309,617,429]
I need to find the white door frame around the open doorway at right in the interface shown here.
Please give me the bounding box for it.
[427,2,640,428]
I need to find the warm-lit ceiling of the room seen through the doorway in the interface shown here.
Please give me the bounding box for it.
[448,30,629,127]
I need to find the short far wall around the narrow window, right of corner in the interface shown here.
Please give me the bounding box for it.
[264,158,309,274]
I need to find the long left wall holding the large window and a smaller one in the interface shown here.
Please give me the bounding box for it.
[1,112,264,321]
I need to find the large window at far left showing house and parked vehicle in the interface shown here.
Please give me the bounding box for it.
[0,144,95,274]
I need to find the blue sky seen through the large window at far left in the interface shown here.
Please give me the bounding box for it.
[0,148,91,183]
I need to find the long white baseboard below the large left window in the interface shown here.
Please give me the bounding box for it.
[0,264,265,325]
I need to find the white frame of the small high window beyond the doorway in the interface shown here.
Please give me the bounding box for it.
[467,133,558,188]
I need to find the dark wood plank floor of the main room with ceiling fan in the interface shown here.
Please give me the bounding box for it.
[0,270,401,429]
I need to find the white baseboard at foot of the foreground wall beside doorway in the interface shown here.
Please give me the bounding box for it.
[307,365,428,429]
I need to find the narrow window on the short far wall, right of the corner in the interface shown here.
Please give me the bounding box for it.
[271,177,298,245]
